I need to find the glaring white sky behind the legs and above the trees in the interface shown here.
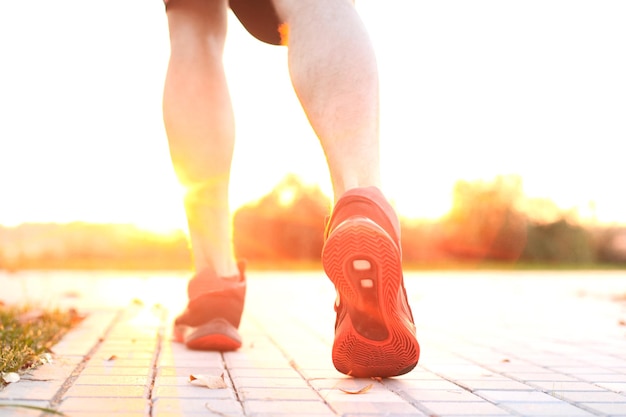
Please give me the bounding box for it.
[0,0,626,229]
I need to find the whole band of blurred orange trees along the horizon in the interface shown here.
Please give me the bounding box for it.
[0,172,626,270]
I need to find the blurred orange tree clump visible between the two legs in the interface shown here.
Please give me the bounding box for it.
[233,175,330,261]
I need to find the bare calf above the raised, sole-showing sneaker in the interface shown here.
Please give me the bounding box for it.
[274,0,380,201]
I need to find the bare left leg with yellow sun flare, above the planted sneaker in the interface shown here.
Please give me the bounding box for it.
[163,0,238,276]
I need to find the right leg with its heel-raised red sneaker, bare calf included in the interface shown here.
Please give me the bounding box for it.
[274,0,420,377]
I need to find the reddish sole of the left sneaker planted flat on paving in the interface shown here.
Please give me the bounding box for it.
[174,319,241,352]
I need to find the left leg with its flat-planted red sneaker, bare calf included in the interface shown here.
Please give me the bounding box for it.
[163,0,246,350]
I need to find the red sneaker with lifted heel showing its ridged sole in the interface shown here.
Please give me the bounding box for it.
[322,187,420,378]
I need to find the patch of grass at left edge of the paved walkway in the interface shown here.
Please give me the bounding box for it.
[0,304,81,389]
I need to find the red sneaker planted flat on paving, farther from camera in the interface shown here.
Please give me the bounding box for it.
[174,262,246,351]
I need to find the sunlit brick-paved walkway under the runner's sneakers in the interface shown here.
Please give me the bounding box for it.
[0,272,626,417]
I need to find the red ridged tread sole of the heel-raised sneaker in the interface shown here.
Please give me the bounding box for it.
[322,217,419,377]
